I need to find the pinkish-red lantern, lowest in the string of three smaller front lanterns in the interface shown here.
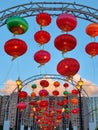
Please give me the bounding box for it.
[34,50,51,65]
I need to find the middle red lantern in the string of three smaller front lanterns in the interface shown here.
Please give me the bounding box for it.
[34,30,50,45]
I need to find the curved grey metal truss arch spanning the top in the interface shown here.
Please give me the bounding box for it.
[0,2,98,27]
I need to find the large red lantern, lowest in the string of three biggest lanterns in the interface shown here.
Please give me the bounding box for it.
[57,58,80,77]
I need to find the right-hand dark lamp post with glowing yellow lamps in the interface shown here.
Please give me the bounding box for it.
[76,78,84,130]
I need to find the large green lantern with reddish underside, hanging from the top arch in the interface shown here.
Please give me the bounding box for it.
[6,16,28,35]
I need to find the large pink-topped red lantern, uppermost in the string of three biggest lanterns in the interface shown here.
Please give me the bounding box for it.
[56,13,77,32]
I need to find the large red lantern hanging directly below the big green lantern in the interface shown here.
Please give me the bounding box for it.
[4,38,27,60]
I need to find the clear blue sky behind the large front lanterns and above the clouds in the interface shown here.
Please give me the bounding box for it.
[0,0,98,93]
